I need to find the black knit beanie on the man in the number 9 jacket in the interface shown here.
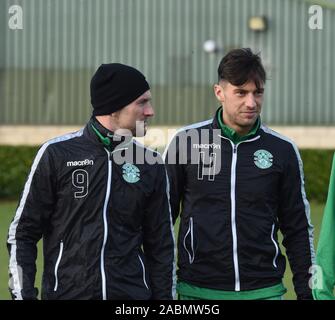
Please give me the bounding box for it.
[91,63,150,116]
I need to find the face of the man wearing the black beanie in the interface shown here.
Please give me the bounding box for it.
[114,90,154,137]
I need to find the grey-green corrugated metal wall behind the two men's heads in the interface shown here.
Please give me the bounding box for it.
[0,0,335,125]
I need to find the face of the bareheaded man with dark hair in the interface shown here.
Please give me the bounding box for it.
[214,81,264,135]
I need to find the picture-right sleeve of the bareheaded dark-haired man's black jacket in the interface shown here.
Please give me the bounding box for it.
[279,145,315,299]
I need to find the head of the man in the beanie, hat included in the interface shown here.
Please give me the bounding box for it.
[91,63,154,136]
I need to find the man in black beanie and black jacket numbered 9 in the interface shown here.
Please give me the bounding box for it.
[7,63,175,300]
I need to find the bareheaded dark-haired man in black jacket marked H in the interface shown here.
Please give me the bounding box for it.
[165,49,314,299]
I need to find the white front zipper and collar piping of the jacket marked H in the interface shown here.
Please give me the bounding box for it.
[219,135,260,291]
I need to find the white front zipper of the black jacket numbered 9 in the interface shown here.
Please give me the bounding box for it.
[100,149,112,300]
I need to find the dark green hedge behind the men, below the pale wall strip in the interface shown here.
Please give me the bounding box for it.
[0,146,334,203]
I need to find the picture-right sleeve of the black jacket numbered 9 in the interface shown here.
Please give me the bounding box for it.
[143,163,175,300]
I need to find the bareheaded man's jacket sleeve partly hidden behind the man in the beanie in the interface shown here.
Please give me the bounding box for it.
[164,135,185,223]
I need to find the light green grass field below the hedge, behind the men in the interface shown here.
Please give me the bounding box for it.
[0,202,324,300]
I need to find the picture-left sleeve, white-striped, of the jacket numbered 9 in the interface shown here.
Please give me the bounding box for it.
[7,145,55,300]
